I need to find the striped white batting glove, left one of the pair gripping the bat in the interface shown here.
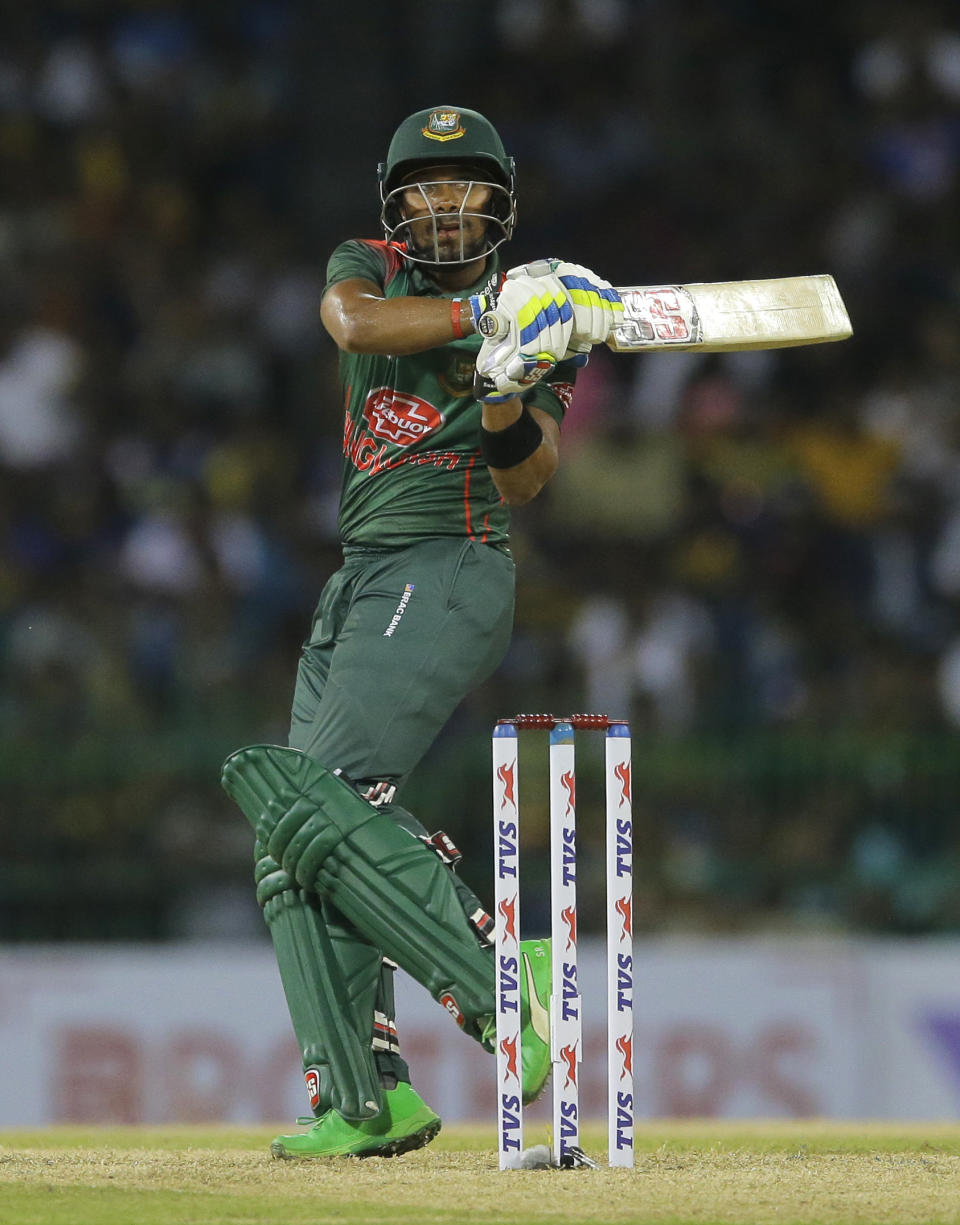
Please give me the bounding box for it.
[474,274,573,403]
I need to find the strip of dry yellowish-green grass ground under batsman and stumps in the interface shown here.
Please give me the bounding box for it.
[0,1120,960,1225]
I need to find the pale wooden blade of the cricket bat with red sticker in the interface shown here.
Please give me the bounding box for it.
[606,273,853,353]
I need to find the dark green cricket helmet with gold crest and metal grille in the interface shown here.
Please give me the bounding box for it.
[377,107,517,263]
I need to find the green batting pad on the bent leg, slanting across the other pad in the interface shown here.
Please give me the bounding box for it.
[223,745,495,1040]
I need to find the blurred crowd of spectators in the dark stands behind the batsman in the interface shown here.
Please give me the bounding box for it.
[0,0,960,938]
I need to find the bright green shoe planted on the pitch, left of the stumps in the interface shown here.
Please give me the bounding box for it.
[271,1080,441,1160]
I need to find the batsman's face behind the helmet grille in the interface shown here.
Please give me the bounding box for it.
[400,165,493,263]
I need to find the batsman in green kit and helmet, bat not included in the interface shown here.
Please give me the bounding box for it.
[223,107,622,1158]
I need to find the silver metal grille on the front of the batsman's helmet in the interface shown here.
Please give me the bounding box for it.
[380,167,517,263]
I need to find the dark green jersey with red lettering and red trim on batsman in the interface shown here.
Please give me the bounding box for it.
[326,239,576,546]
